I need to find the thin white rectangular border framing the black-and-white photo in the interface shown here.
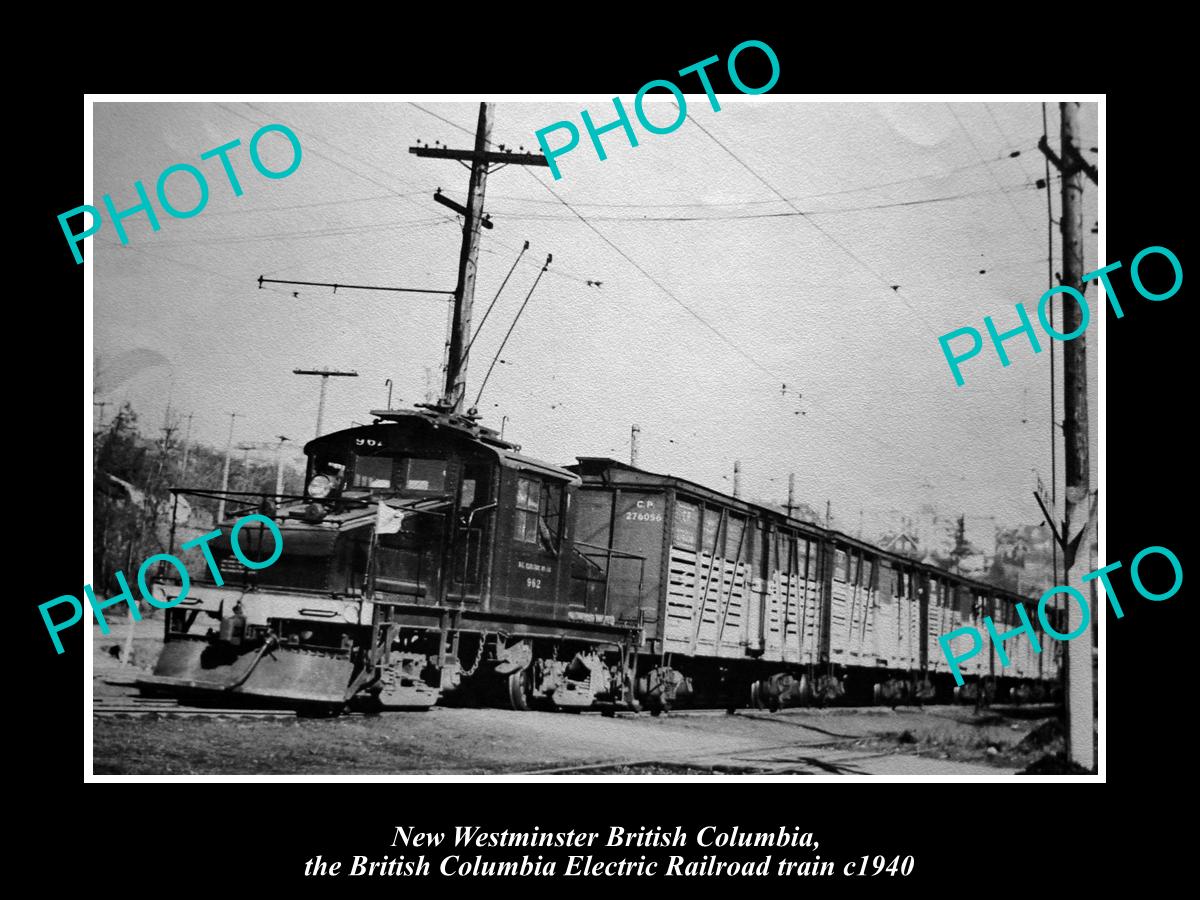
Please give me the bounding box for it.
[79,94,1108,785]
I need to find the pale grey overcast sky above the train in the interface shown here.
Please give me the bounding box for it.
[88,95,1103,532]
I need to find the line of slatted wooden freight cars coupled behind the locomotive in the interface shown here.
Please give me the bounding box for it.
[566,457,1056,710]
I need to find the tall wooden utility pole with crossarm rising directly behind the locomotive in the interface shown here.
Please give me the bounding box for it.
[408,103,548,413]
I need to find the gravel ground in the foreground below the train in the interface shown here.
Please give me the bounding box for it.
[94,670,1060,775]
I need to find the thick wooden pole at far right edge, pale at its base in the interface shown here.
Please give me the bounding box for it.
[1060,102,1099,769]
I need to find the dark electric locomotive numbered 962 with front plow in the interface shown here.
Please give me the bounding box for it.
[140,404,642,709]
